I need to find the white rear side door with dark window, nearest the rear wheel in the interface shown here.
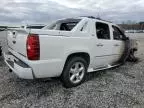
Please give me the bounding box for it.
[94,22,113,68]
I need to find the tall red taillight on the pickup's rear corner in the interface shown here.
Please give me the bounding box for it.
[26,34,40,60]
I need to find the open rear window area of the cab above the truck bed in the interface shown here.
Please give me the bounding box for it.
[43,19,81,31]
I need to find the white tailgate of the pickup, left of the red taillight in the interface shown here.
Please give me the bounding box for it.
[7,29,29,56]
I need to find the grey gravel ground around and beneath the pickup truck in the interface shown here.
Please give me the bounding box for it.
[0,37,144,108]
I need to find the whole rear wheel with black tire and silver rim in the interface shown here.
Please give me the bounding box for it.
[61,57,88,88]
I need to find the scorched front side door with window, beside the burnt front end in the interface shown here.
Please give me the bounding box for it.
[112,25,125,62]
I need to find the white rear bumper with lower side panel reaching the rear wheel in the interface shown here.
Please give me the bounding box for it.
[4,48,64,79]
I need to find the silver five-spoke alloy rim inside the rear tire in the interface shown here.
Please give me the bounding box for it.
[69,62,85,84]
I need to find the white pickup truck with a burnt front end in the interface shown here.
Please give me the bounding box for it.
[4,17,137,87]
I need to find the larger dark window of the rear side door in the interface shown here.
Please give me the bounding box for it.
[96,22,110,39]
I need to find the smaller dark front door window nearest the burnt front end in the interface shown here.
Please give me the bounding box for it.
[112,26,125,40]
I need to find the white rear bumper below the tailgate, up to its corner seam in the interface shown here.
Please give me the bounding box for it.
[4,53,34,79]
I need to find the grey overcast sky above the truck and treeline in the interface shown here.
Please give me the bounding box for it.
[0,0,144,24]
